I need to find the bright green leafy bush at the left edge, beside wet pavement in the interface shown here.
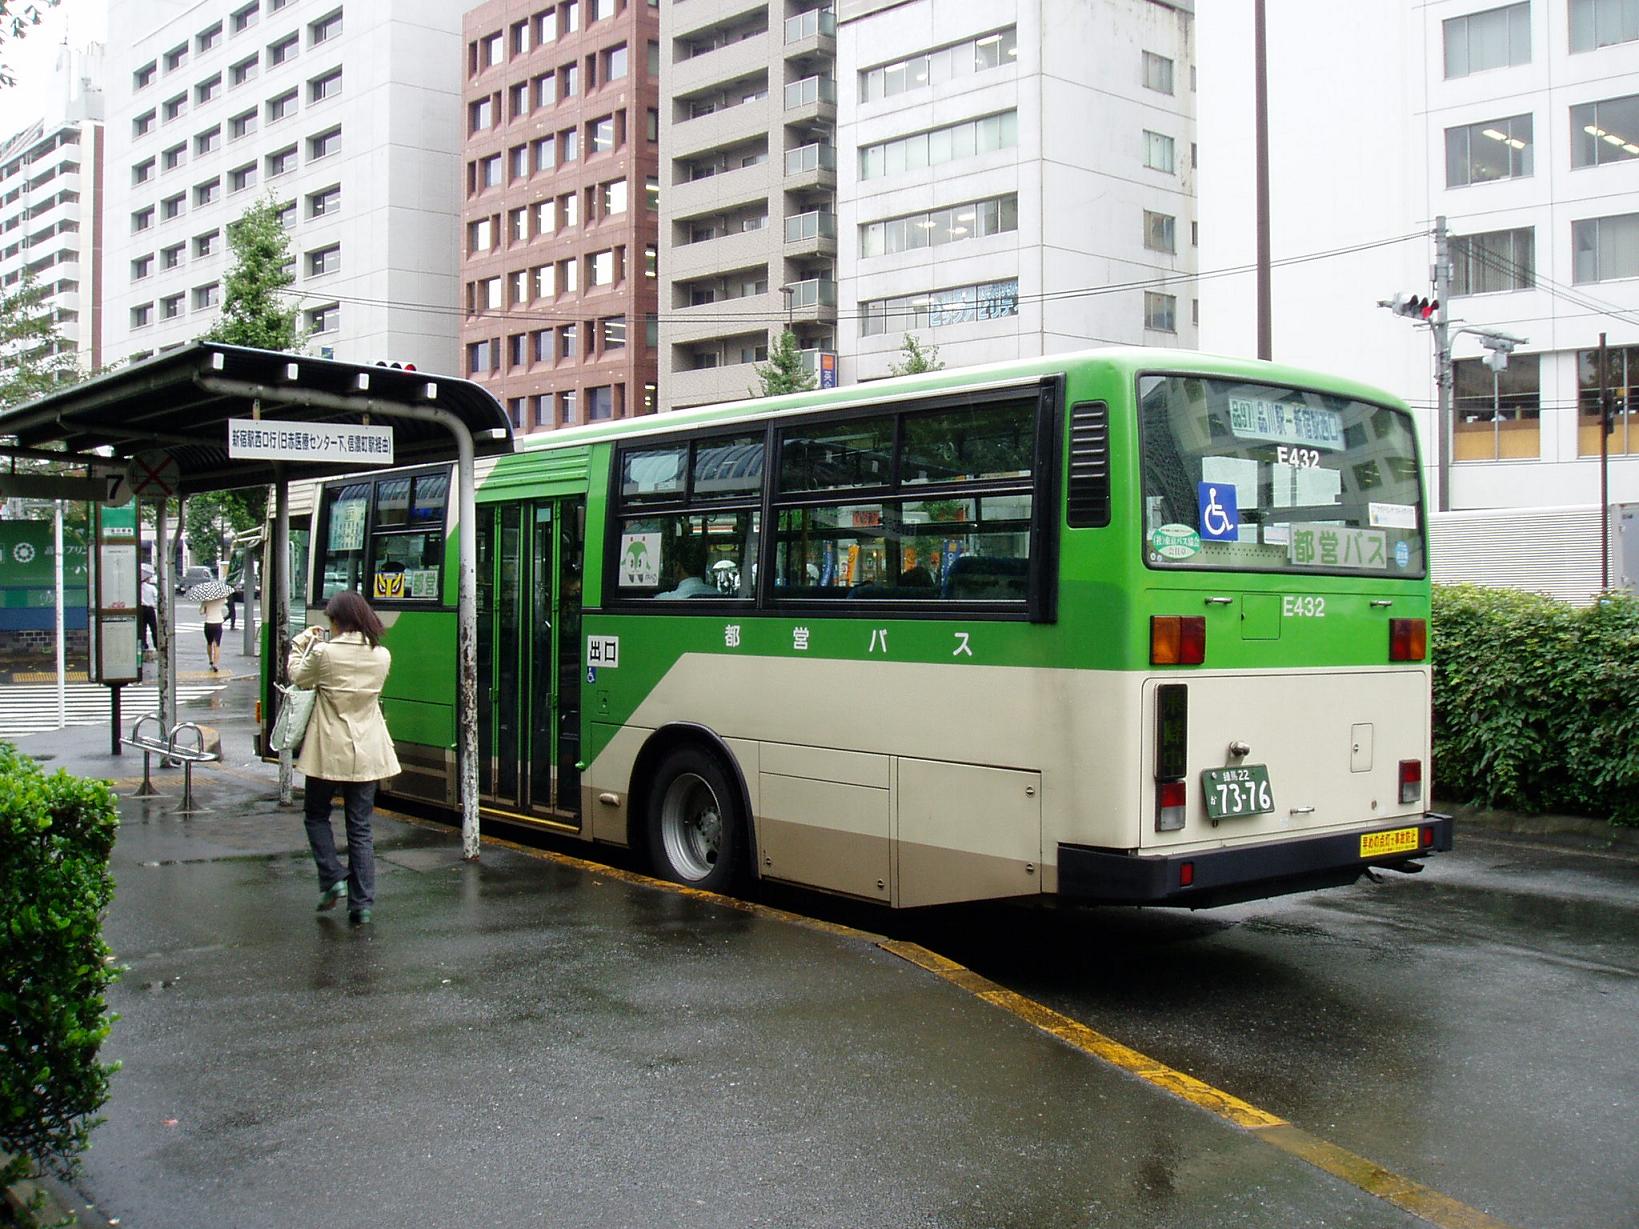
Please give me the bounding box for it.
[0,742,120,1186]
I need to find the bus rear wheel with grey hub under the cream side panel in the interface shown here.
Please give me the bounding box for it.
[647,747,742,891]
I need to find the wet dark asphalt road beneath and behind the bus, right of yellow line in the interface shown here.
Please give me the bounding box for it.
[895,829,1639,1229]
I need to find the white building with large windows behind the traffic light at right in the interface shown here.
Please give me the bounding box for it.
[1201,0,1639,511]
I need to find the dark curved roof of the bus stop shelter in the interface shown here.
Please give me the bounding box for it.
[0,341,513,495]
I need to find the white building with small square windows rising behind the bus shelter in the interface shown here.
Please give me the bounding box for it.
[107,0,462,372]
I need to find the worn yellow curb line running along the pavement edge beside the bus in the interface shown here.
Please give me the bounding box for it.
[365,808,1513,1229]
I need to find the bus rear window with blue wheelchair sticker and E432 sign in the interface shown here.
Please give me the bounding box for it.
[1139,375,1424,578]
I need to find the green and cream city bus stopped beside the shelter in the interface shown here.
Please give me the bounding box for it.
[262,349,1451,908]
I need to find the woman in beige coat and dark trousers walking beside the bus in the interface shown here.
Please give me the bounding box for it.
[288,590,398,924]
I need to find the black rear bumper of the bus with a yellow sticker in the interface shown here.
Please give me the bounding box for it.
[1059,811,1452,909]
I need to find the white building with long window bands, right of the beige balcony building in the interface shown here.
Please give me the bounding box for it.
[836,0,1196,382]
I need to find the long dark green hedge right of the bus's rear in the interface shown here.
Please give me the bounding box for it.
[1431,585,1639,824]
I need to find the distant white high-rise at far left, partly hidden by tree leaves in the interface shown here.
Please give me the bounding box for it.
[0,44,103,372]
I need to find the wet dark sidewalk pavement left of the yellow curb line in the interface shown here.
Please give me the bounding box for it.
[3,665,1419,1229]
